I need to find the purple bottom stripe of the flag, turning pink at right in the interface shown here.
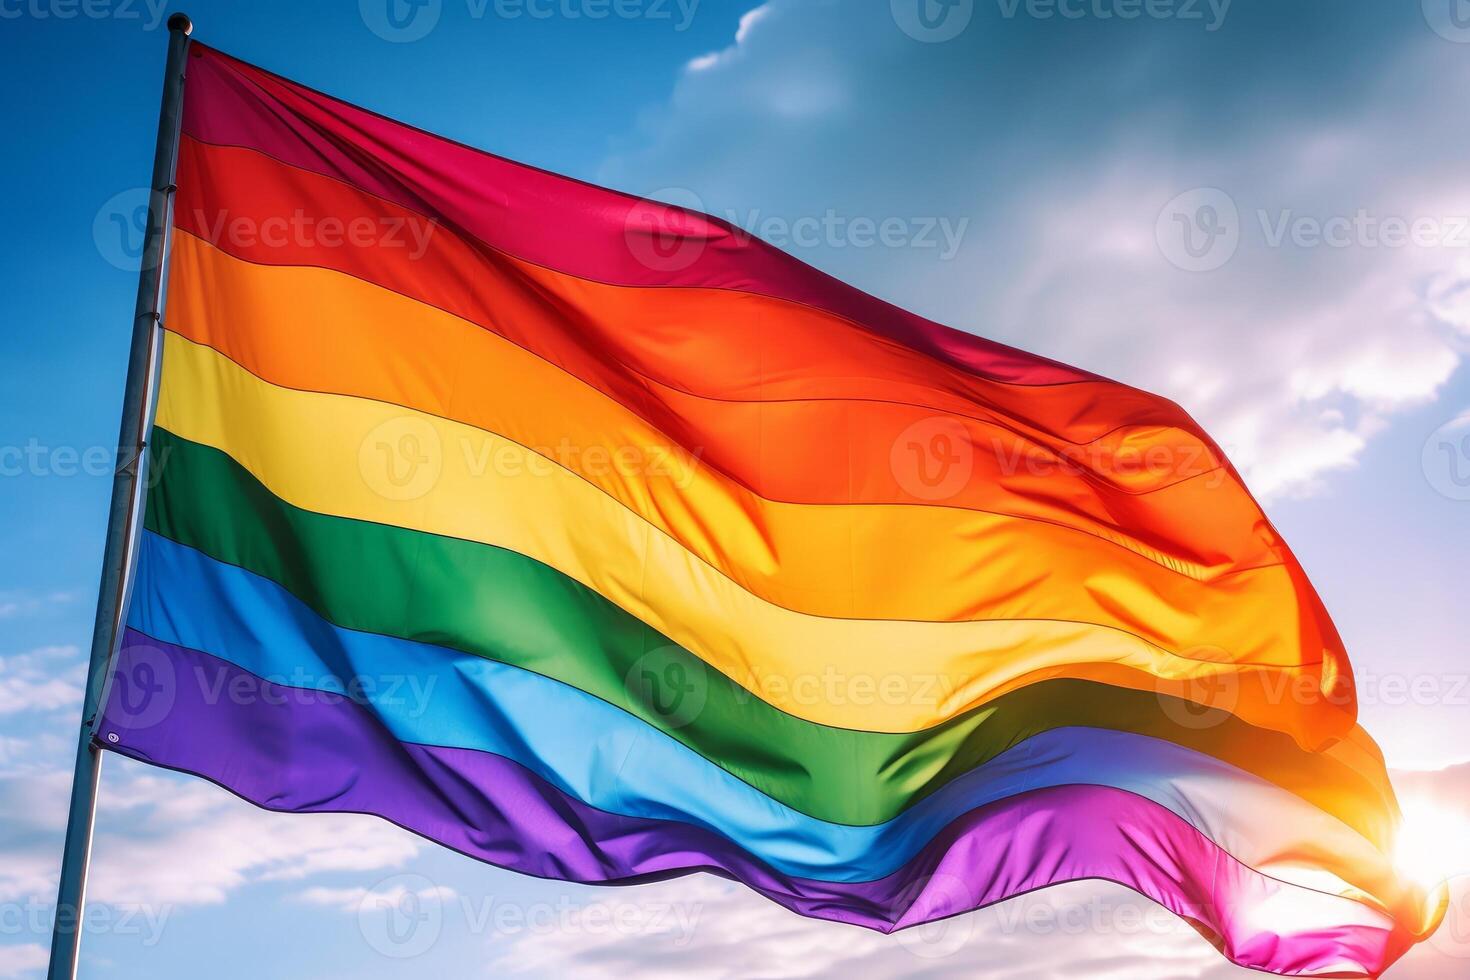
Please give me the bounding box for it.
[98,630,1407,976]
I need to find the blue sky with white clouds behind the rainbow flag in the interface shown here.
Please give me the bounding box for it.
[0,0,1470,980]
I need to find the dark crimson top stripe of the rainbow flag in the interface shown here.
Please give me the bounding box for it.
[184,44,1097,385]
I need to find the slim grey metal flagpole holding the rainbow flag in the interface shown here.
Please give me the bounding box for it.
[47,13,194,980]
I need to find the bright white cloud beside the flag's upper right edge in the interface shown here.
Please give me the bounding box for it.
[993,166,1460,498]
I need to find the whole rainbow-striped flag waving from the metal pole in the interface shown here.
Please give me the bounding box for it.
[97,44,1442,976]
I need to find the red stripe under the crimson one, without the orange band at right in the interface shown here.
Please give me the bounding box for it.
[175,138,1214,470]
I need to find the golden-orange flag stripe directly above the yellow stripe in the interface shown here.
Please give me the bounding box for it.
[169,232,1346,678]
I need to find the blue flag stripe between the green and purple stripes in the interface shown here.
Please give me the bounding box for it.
[128,532,1328,882]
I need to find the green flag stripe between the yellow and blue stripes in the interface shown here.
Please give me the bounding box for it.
[144,429,1386,839]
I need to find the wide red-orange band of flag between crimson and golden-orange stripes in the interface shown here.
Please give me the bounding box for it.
[175,140,1283,570]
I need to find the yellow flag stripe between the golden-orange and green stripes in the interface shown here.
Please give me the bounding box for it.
[157,335,1342,741]
